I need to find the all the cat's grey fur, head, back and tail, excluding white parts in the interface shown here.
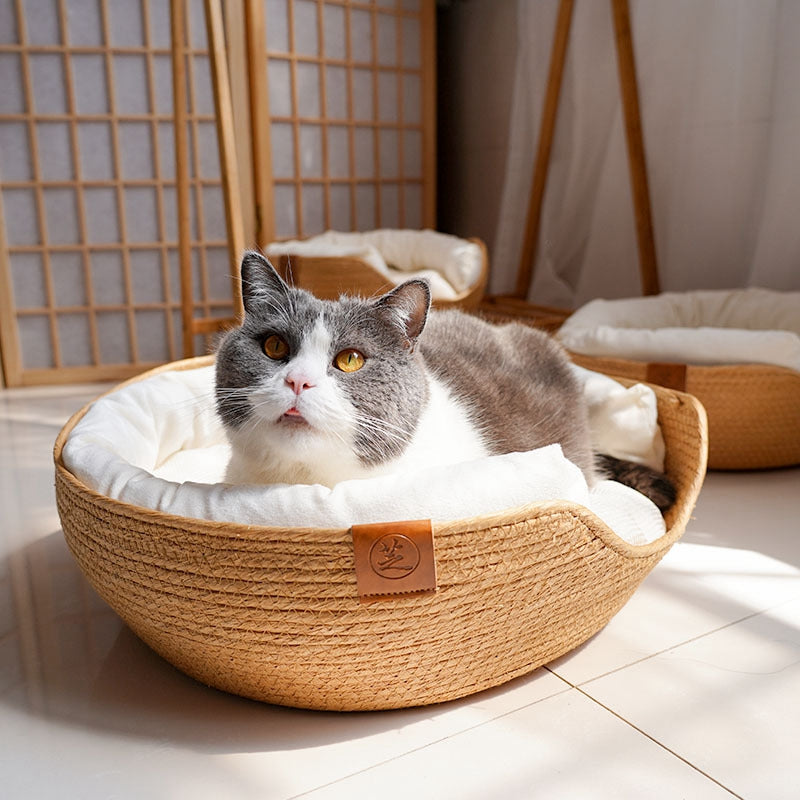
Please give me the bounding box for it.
[216,253,674,510]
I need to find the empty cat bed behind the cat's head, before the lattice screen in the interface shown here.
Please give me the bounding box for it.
[265,228,489,309]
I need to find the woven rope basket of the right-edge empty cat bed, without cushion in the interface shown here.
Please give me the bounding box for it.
[570,353,800,469]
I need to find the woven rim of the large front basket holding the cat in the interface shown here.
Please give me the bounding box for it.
[53,355,707,559]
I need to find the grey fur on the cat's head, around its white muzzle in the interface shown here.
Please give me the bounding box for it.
[216,252,430,466]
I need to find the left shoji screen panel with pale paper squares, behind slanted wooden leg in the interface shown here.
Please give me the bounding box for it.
[0,0,232,385]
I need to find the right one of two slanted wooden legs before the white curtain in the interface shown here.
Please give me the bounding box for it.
[611,0,661,295]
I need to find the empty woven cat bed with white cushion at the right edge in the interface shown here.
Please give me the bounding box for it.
[558,289,800,469]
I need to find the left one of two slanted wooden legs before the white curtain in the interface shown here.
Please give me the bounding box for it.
[514,0,574,299]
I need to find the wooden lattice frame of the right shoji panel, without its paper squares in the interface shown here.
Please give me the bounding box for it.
[245,0,436,247]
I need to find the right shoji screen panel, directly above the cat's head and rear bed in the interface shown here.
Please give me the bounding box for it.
[248,0,435,246]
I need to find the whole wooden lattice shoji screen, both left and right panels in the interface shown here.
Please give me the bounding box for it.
[0,0,435,385]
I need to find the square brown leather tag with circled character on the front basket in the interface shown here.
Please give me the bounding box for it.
[350,520,436,601]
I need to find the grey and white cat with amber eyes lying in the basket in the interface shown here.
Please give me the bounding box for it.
[216,252,673,510]
